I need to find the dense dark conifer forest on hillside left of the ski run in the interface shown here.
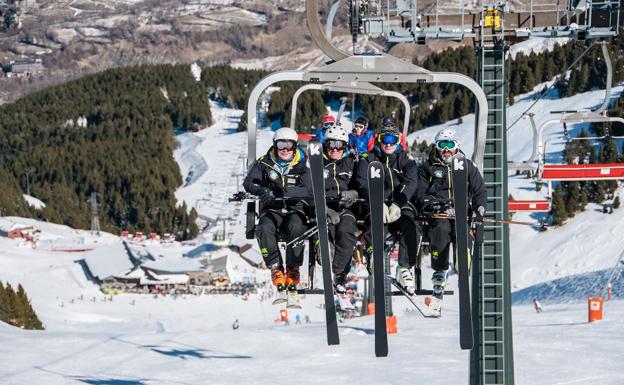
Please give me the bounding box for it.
[0,65,212,239]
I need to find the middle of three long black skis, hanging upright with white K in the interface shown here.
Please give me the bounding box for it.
[367,161,388,357]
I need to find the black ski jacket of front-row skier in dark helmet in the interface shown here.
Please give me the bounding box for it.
[357,147,426,207]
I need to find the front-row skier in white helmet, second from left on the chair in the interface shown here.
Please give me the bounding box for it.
[310,127,358,293]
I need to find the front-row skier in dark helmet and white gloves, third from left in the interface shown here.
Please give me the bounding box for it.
[357,124,422,294]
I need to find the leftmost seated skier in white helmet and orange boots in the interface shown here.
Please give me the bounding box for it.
[243,127,311,297]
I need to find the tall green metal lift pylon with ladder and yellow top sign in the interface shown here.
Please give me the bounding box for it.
[470,6,514,385]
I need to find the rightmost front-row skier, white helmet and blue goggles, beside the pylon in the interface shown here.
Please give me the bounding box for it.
[417,129,487,299]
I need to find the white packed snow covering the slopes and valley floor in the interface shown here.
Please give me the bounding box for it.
[0,73,624,385]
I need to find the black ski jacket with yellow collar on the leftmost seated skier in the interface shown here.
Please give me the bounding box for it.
[243,147,312,213]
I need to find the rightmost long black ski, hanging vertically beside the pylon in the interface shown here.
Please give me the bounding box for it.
[452,153,474,349]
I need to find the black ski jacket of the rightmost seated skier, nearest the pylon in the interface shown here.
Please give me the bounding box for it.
[416,149,487,210]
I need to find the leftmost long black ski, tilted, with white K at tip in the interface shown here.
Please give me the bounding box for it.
[308,139,340,345]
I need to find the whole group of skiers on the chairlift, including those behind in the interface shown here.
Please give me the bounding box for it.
[243,115,486,296]
